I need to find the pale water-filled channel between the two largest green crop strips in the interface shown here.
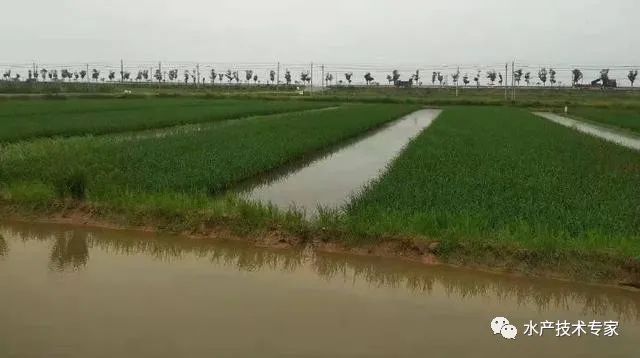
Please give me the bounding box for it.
[243,109,441,217]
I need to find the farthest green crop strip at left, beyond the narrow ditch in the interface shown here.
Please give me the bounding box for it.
[0,98,330,142]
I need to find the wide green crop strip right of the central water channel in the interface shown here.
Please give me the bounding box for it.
[344,107,640,257]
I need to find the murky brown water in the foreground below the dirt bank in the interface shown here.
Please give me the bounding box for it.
[0,223,640,358]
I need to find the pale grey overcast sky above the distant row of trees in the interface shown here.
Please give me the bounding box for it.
[0,0,640,65]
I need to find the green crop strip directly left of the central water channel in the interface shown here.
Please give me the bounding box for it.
[0,105,416,201]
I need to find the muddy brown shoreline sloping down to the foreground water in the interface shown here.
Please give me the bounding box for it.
[0,205,640,292]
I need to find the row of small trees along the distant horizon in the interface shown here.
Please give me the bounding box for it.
[2,68,638,87]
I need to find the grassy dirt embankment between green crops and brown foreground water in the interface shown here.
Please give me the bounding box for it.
[0,206,640,289]
